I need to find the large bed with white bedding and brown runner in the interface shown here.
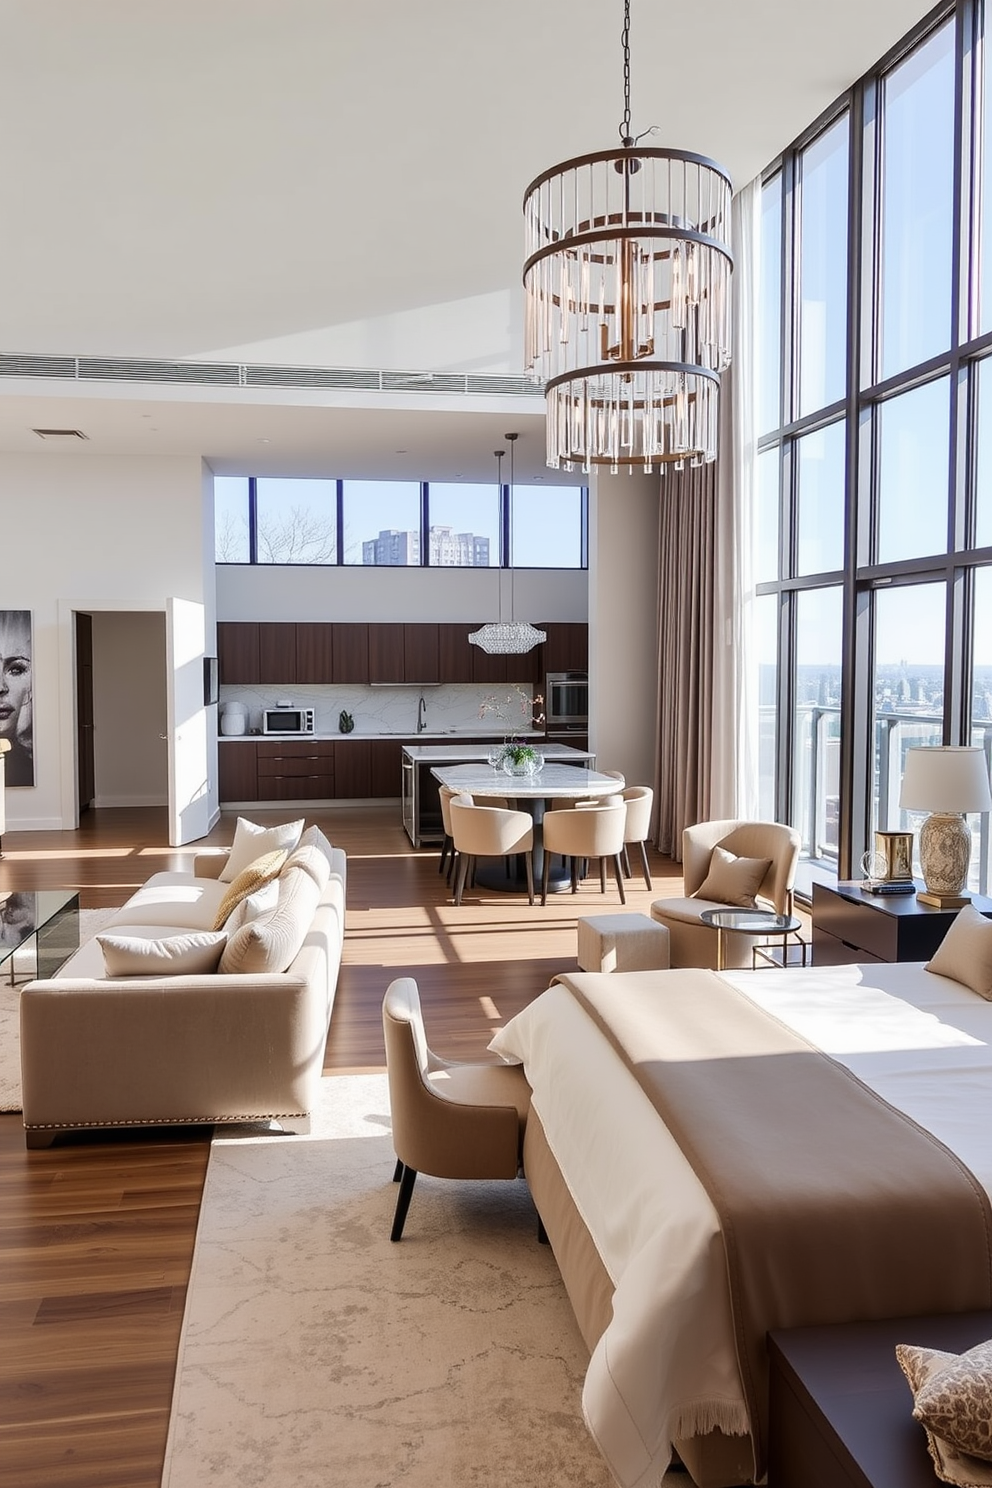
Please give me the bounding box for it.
[491,963,992,1488]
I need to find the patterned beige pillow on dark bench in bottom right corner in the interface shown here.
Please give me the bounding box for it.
[895,1342,992,1484]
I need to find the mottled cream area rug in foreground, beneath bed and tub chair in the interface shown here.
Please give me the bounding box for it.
[162,1074,689,1488]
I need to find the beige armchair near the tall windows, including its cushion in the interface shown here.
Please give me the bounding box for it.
[651,818,802,970]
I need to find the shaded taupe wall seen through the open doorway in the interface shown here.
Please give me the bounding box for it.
[92,610,168,806]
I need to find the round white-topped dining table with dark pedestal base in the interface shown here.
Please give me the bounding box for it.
[431,763,625,893]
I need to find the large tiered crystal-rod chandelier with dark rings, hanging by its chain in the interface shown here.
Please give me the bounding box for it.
[524,0,733,472]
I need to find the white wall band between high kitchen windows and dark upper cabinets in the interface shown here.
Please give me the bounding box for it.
[217,564,589,622]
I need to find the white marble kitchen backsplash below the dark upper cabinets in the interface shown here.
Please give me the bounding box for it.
[219,683,543,738]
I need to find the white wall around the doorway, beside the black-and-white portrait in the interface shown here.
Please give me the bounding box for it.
[0,451,216,829]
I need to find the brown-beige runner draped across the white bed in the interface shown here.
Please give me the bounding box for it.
[555,970,992,1478]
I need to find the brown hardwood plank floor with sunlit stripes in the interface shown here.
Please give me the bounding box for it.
[0,805,681,1488]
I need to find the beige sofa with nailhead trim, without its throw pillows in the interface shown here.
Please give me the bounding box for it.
[21,829,347,1147]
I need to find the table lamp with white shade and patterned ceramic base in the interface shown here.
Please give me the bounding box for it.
[898,744,992,909]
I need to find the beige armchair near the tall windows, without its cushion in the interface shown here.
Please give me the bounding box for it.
[651,820,802,970]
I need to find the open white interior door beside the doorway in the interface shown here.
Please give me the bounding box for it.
[165,598,210,847]
